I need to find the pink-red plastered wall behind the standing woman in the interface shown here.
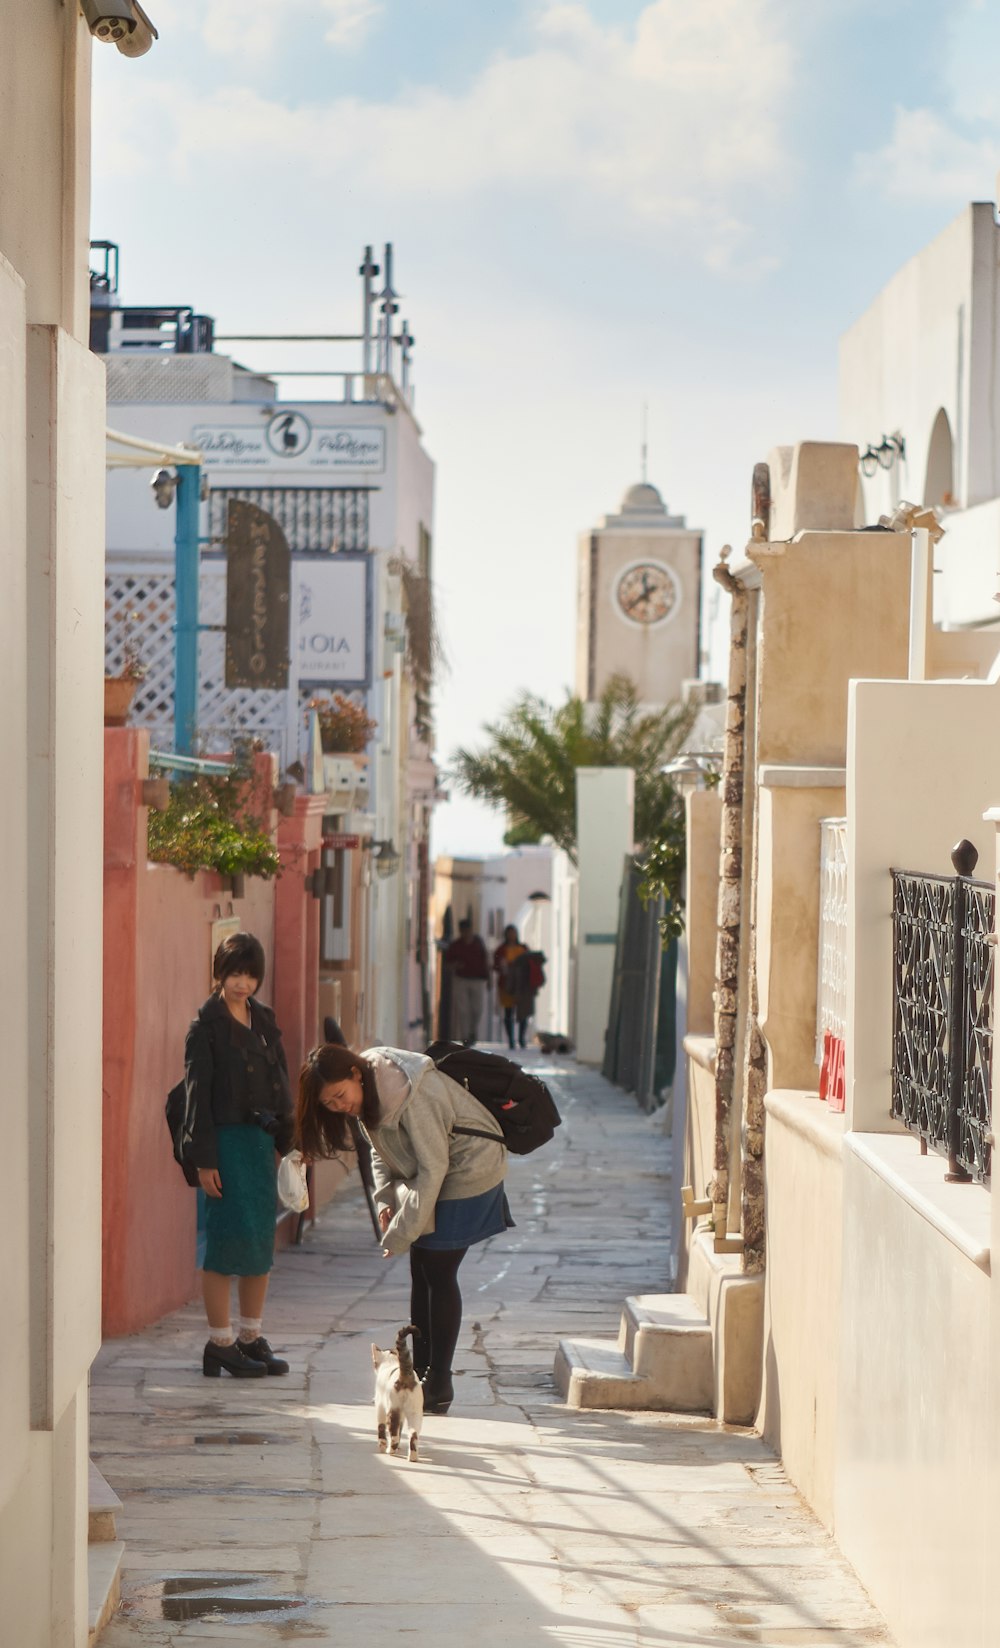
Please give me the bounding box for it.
[104,727,285,1337]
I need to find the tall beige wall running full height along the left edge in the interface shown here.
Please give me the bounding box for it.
[0,0,104,1648]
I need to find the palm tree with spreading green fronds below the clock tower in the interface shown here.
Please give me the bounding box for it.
[451,676,694,865]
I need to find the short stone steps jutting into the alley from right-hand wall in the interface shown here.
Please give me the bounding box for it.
[554,1233,763,1426]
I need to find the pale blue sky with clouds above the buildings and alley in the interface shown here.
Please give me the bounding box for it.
[92,0,1000,854]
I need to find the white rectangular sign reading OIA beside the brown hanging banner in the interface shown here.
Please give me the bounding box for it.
[292,550,371,687]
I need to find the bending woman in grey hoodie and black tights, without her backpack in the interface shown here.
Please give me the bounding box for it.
[298,1045,514,1414]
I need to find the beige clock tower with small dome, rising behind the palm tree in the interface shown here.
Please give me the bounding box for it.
[577,481,702,704]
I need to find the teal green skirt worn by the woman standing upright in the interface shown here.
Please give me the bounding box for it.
[204,1122,277,1276]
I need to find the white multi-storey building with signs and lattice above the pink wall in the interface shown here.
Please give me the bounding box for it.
[99,242,437,1043]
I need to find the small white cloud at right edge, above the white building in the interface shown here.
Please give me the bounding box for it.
[855,107,1000,208]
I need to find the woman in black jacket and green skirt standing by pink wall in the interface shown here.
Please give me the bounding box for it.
[185,933,292,1379]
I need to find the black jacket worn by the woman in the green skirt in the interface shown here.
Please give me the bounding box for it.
[185,995,293,1167]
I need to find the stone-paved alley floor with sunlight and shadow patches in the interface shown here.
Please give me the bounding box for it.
[92,1056,888,1648]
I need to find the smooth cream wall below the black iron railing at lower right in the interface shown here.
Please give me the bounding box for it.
[835,1139,997,1648]
